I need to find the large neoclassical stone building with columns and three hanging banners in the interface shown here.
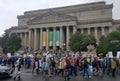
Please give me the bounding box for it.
[7,1,120,50]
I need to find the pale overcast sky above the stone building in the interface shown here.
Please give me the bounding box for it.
[0,0,120,36]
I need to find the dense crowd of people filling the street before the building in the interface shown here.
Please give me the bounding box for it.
[0,50,120,80]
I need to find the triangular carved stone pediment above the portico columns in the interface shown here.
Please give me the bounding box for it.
[28,11,76,24]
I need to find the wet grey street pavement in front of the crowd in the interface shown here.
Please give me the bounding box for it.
[0,69,120,81]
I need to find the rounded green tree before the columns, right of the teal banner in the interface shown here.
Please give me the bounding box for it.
[69,32,96,51]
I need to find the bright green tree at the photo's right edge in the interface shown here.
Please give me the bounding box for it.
[98,27,120,55]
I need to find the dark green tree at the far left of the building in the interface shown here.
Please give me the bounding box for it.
[2,33,21,54]
